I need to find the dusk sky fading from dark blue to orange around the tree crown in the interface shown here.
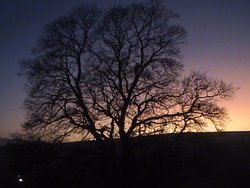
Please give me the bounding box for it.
[0,0,250,137]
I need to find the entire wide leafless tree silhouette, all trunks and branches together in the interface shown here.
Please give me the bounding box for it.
[21,0,235,182]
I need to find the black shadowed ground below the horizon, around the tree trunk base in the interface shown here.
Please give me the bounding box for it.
[0,132,250,188]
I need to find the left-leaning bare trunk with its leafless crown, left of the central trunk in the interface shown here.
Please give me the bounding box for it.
[21,5,100,141]
